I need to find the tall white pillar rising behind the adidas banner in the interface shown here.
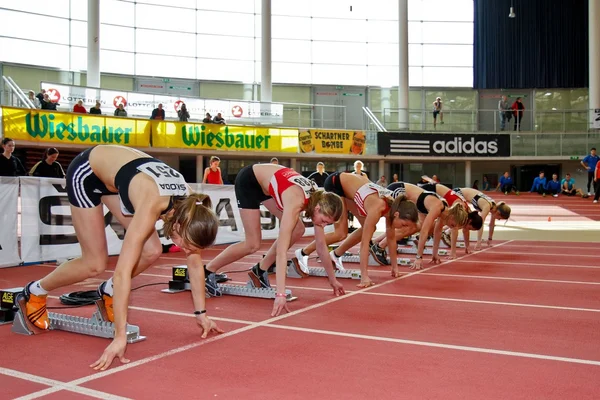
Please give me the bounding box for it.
[398,0,408,129]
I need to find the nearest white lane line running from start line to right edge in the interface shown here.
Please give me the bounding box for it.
[266,325,600,366]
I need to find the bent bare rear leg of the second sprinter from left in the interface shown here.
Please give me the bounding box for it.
[206,209,262,272]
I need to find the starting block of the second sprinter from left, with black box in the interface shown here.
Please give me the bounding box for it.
[161,265,298,301]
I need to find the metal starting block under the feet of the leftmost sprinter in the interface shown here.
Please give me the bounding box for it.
[12,294,146,343]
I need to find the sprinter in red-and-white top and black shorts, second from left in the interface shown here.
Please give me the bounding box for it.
[205,164,344,316]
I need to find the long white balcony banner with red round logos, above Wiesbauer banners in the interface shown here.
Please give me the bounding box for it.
[41,82,283,125]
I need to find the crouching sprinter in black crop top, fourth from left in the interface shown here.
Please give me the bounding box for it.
[376,182,468,269]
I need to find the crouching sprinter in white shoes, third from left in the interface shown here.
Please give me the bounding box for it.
[292,172,417,287]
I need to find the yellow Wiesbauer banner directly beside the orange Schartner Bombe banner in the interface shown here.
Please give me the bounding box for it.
[152,121,298,153]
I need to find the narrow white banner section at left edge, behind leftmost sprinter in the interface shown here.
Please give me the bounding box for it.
[0,176,21,267]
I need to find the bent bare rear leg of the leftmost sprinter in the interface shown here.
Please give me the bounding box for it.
[40,205,109,292]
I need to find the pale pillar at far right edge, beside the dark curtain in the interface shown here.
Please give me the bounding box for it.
[588,0,600,127]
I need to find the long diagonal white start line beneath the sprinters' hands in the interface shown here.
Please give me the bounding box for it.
[18,241,512,400]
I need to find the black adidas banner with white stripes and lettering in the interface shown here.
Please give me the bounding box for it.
[377,132,510,157]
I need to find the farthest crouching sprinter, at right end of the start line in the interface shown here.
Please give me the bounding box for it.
[454,188,511,254]
